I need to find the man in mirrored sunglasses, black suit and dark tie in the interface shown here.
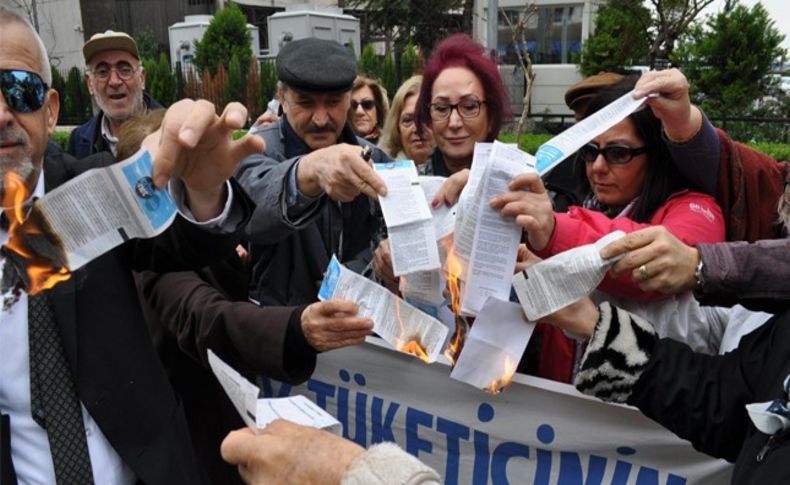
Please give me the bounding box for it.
[0,6,263,485]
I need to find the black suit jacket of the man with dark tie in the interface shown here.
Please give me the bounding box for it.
[9,146,251,485]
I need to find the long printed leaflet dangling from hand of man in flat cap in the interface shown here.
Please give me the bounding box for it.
[374,160,441,276]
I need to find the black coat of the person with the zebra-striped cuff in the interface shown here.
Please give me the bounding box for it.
[628,310,790,485]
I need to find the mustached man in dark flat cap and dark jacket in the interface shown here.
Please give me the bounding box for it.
[237,38,389,305]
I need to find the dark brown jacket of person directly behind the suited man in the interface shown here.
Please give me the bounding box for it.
[137,255,316,484]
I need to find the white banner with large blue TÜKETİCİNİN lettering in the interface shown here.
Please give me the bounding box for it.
[261,338,731,485]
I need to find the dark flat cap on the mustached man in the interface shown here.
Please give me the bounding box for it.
[277,37,357,92]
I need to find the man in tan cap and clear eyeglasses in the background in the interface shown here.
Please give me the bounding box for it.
[68,30,162,158]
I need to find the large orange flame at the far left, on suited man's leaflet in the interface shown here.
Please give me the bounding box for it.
[2,172,71,295]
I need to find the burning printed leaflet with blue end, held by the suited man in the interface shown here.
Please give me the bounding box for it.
[2,150,176,294]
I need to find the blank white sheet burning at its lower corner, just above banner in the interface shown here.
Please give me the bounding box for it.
[450,298,535,394]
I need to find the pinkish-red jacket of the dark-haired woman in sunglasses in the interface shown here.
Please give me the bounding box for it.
[537,190,725,301]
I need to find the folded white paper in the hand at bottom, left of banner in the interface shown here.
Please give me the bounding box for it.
[208,350,340,434]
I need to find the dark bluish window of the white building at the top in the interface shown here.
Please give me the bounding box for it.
[497,4,583,64]
